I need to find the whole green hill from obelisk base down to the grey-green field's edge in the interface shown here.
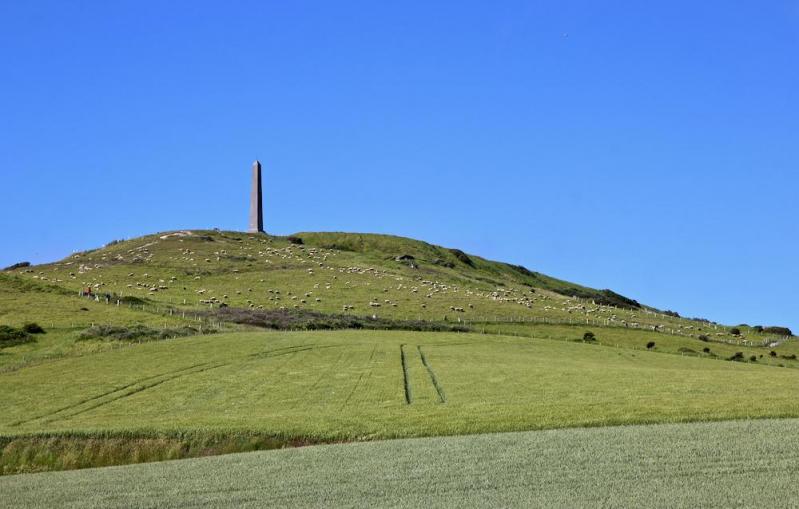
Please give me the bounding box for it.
[0,231,799,473]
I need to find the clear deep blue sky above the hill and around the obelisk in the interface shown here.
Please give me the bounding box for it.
[0,0,799,332]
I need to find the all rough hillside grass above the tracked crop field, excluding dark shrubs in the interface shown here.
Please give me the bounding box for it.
[0,231,799,371]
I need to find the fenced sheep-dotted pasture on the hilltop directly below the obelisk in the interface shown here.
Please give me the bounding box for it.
[0,230,780,337]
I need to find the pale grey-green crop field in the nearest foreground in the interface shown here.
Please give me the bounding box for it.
[0,420,799,509]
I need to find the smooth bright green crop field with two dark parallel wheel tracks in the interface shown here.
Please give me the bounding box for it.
[0,331,799,470]
